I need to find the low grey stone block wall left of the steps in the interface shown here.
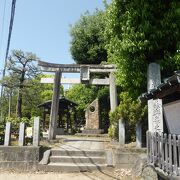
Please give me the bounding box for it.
[0,146,41,171]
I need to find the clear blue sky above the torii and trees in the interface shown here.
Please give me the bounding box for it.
[0,0,111,75]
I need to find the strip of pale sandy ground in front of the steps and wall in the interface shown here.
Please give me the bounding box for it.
[0,169,134,180]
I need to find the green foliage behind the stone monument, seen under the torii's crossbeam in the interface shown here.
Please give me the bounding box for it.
[65,84,110,131]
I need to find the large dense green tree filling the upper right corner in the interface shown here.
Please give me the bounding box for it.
[105,0,180,98]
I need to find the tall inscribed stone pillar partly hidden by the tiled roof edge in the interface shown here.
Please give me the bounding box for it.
[147,63,163,133]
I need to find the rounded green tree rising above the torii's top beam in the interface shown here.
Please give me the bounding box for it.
[70,10,107,64]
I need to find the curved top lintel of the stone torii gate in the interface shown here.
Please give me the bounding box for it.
[38,61,116,73]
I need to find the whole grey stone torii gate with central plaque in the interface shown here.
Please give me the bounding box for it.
[38,61,117,140]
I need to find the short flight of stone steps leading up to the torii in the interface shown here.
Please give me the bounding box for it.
[39,148,107,172]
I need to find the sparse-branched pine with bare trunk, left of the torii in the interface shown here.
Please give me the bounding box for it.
[2,50,39,118]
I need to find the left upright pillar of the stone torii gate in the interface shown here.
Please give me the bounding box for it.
[48,70,62,140]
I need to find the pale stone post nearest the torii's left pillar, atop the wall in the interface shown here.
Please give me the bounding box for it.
[33,117,40,146]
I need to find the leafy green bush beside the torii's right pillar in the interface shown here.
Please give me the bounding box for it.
[109,92,147,139]
